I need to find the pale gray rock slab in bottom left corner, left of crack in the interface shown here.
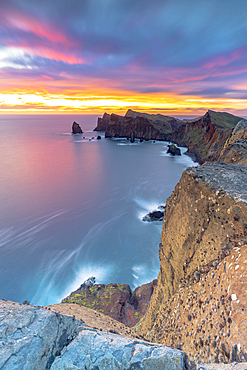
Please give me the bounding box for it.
[0,300,82,370]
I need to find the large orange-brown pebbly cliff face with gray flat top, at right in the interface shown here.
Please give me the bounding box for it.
[138,162,247,362]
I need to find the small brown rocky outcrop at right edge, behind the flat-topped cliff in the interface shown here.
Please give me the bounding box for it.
[219,119,247,164]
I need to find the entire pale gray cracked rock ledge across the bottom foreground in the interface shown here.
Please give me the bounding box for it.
[0,300,193,370]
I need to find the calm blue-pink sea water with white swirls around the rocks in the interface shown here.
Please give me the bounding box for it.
[0,115,195,305]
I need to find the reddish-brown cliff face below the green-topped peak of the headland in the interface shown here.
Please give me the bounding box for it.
[166,110,241,164]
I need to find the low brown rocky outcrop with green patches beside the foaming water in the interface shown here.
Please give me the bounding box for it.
[62,280,157,327]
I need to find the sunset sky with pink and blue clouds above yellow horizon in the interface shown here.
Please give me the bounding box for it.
[0,0,247,116]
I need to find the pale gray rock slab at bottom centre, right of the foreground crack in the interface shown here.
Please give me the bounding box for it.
[51,330,190,370]
